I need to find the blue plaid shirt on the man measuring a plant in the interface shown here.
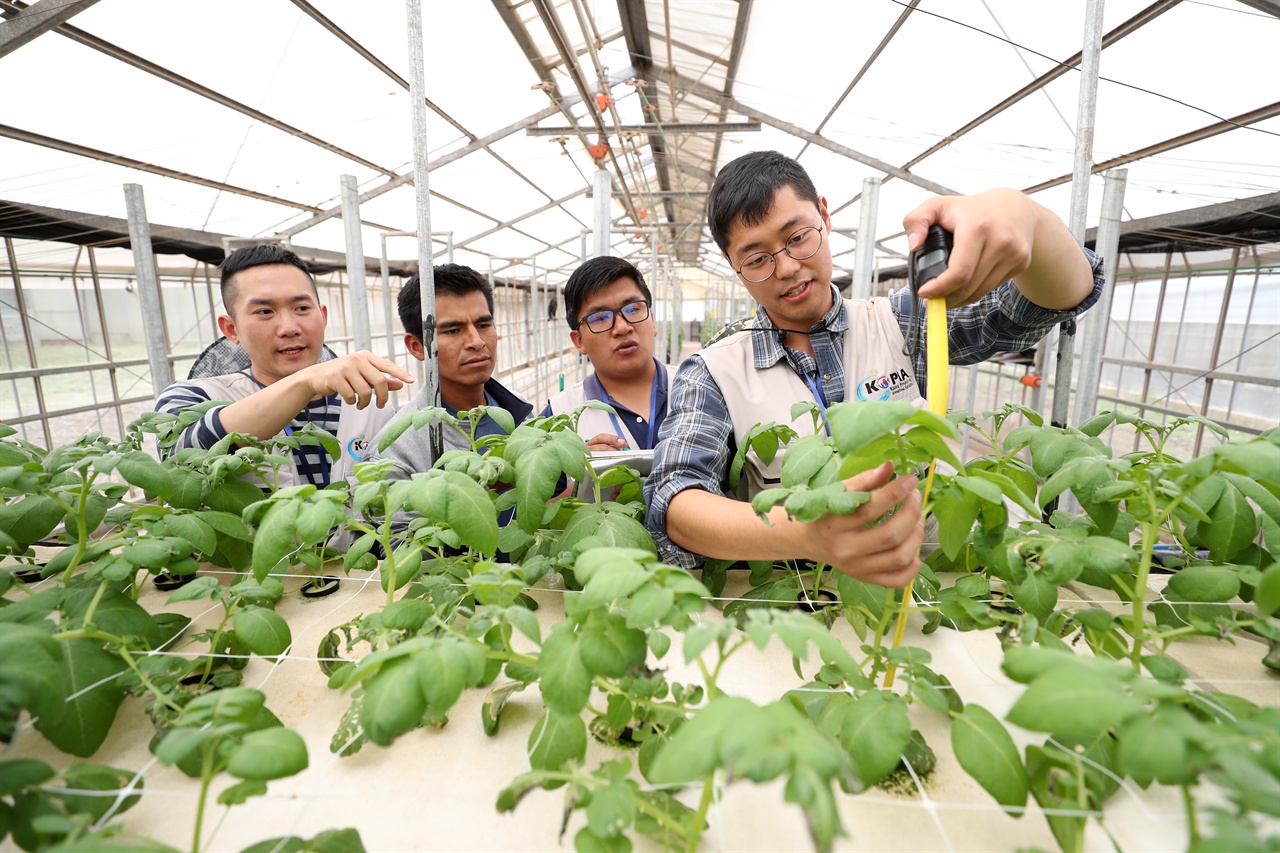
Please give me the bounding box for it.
[645,248,1103,569]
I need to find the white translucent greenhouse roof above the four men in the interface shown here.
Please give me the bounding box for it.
[0,0,1280,279]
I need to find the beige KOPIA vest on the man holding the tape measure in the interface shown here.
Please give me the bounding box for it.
[698,297,925,501]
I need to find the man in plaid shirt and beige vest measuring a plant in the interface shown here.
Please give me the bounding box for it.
[645,151,1102,587]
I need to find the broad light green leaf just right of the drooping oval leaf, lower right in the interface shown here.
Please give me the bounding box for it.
[1009,666,1142,739]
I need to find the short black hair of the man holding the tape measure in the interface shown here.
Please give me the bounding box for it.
[707,151,818,254]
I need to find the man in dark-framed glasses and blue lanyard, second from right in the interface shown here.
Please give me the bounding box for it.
[543,256,667,452]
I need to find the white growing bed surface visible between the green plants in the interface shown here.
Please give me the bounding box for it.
[0,558,1280,852]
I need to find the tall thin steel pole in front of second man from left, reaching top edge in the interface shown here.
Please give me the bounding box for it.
[404,0,444,459]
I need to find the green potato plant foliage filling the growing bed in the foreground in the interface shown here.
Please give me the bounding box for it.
[0,403,1280,853]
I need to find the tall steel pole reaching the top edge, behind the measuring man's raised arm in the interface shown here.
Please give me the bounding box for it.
[1037,0,1105,427]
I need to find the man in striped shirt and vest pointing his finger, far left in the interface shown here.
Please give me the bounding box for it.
[155,245,412,488]
